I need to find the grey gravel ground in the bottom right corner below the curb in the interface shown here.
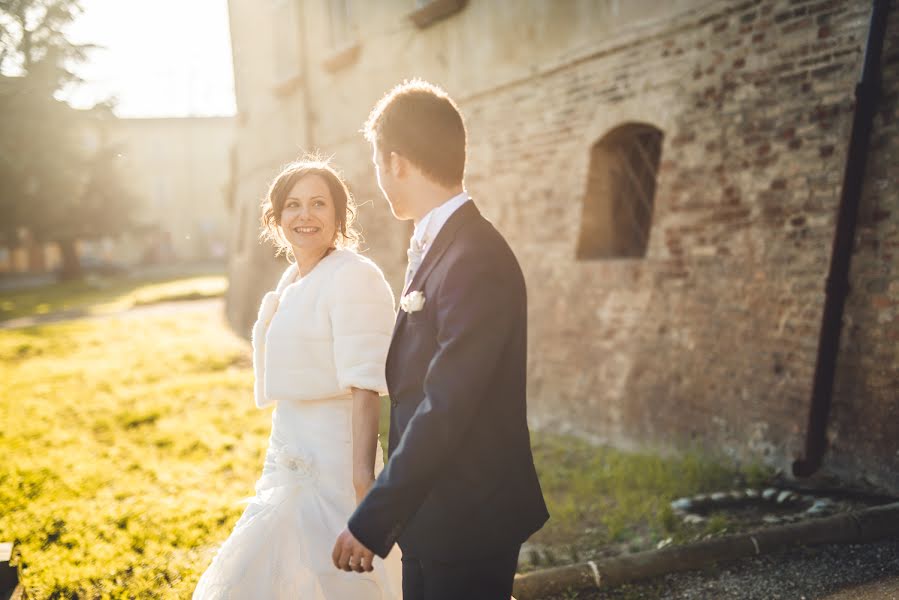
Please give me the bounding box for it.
[545,540,899,600]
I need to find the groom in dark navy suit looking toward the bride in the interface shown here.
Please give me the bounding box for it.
[333,80,549,600]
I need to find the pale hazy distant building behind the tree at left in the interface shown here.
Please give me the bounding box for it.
[0,117,234,273]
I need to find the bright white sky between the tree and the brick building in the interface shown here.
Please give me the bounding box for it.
[64,0,236,117]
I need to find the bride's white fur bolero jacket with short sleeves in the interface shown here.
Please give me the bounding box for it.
[253,250,396,408]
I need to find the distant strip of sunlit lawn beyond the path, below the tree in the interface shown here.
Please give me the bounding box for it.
[0,274,228,321]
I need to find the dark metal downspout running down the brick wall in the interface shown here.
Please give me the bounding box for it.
[793,0,889,477]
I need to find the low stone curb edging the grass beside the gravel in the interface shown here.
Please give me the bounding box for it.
[514,502,899,600]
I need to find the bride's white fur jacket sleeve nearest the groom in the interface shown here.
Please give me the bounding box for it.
[330,260,396,394]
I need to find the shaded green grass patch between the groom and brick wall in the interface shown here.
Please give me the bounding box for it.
[519,432,746,571]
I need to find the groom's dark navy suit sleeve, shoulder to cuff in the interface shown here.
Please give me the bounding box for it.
[349,248,526,556]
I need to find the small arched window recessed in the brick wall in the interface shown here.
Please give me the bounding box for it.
[577,123,664,260]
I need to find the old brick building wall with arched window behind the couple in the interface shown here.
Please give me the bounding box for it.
[228,0,899,490]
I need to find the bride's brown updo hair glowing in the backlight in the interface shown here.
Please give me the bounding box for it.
[259,156,362,258]
